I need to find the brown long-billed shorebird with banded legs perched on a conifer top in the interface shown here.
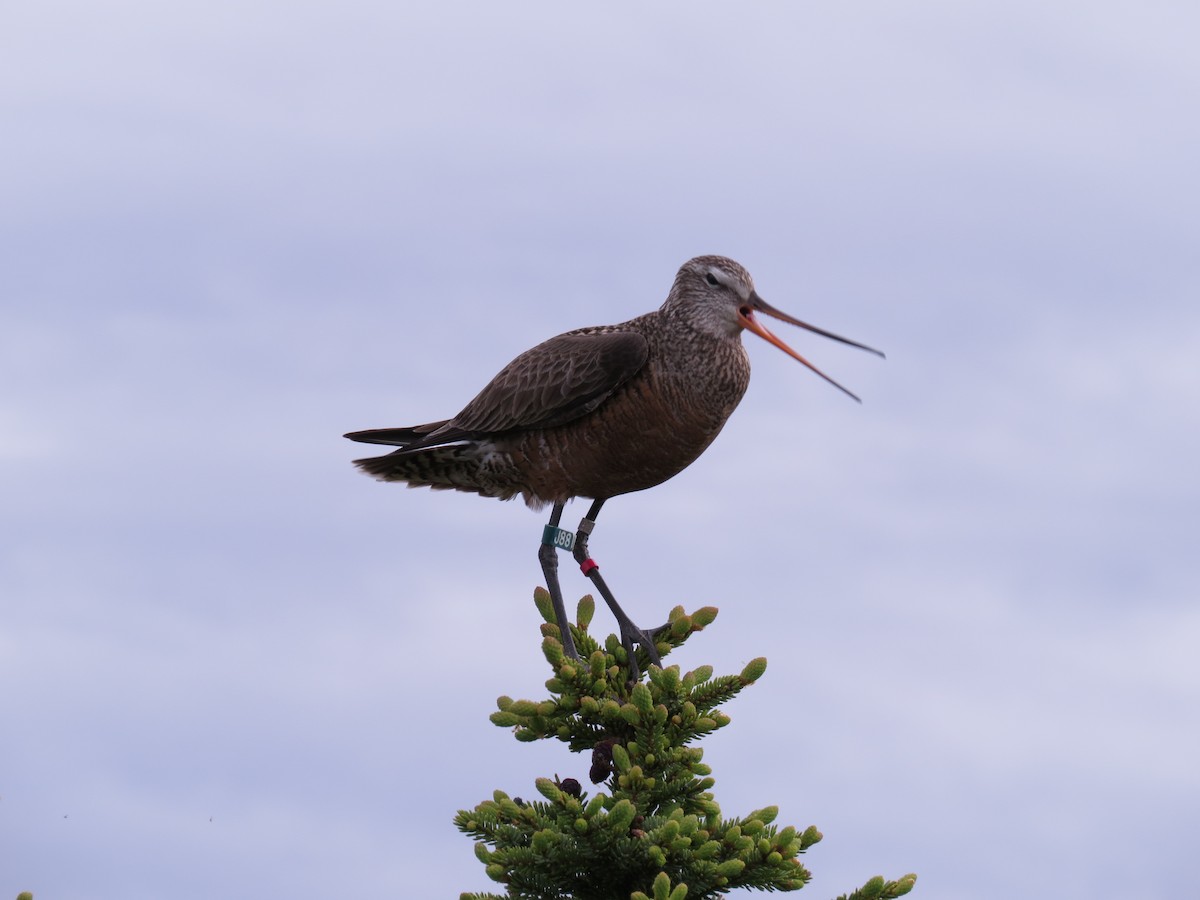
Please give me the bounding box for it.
[346,256,883,668]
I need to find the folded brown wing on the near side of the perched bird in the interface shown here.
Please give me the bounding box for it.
[444,330,649,443]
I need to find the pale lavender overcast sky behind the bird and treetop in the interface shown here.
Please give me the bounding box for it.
[0,0,1200,900]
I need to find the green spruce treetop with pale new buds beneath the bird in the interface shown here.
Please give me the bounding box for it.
[455,589,916,900]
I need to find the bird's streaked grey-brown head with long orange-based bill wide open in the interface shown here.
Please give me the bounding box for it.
[662,256,883,400]
